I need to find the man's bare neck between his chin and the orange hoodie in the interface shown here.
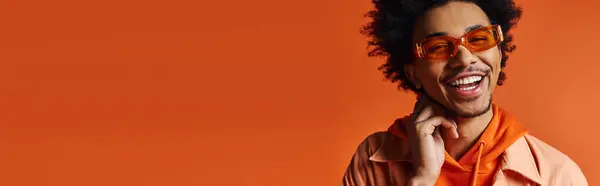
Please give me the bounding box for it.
[442,108,494,160]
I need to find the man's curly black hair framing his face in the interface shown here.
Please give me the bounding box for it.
[360,0,522,91]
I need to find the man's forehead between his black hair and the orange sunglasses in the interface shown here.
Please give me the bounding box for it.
[414,1,490,40]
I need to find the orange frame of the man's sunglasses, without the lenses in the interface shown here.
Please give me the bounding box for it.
[414,25,504,59]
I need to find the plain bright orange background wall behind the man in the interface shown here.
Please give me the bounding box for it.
[0,0,600,186]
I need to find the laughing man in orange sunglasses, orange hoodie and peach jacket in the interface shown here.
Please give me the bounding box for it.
[342,0,587,186]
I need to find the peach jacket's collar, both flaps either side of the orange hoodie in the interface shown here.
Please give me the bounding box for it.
[369,132,542,184]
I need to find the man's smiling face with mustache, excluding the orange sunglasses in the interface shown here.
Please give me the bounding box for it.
[407,2,502,118]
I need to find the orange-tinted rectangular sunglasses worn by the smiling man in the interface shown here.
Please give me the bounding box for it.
[415,25,504,60]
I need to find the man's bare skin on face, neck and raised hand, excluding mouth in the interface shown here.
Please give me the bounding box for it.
[406,2,502,185]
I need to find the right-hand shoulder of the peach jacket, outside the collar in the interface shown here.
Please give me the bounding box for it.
[524,134,587,185]
